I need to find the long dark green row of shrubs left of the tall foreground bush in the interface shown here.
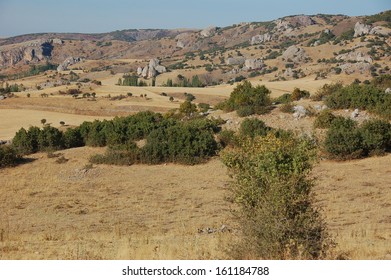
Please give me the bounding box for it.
[12,112,219,165]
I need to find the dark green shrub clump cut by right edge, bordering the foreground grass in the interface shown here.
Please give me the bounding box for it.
[324,117,391,160]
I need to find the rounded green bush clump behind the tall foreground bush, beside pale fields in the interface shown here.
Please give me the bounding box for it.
[218,81,271,117]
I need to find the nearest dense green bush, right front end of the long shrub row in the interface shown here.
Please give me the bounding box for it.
[91,119,218,165]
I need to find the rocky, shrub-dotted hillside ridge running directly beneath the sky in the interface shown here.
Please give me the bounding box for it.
[0,11,391,79]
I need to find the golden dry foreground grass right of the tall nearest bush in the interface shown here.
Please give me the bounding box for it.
[313,155,391,259]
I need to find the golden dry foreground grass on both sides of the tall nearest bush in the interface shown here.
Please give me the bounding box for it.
[0,148,391,259]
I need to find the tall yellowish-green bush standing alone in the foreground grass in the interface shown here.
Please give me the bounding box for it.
[222,134,332,259]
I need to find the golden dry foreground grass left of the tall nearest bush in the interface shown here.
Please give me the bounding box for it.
[0,148,236,259]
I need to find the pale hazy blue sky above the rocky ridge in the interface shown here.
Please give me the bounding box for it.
[0,0,391,37]
